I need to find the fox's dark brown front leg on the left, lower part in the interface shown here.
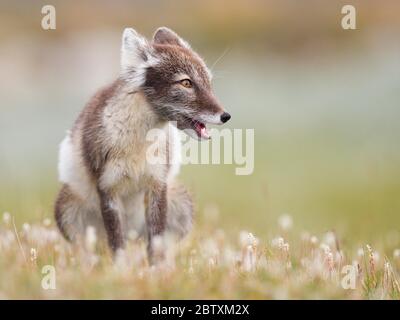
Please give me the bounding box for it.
[98,189,125,254]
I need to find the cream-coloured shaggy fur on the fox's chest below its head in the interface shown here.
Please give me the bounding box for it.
[101,94,180,193]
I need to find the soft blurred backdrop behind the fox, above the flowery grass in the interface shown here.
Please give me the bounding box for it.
[0,0,400,248]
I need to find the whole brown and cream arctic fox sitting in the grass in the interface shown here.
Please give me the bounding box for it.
[55,27,230,263]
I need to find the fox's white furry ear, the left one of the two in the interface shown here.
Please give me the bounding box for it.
[121,28,150,70]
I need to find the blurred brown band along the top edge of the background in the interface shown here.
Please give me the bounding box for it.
[0,0,400,54]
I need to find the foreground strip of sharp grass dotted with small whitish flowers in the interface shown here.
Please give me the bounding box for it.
[0,208,400,299]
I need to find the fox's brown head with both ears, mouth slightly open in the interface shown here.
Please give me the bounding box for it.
[121,27,231,139]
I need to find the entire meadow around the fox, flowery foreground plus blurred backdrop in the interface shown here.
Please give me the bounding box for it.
[0,0,400,299]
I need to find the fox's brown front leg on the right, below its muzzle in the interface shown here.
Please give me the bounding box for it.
[146,184,167,264]
